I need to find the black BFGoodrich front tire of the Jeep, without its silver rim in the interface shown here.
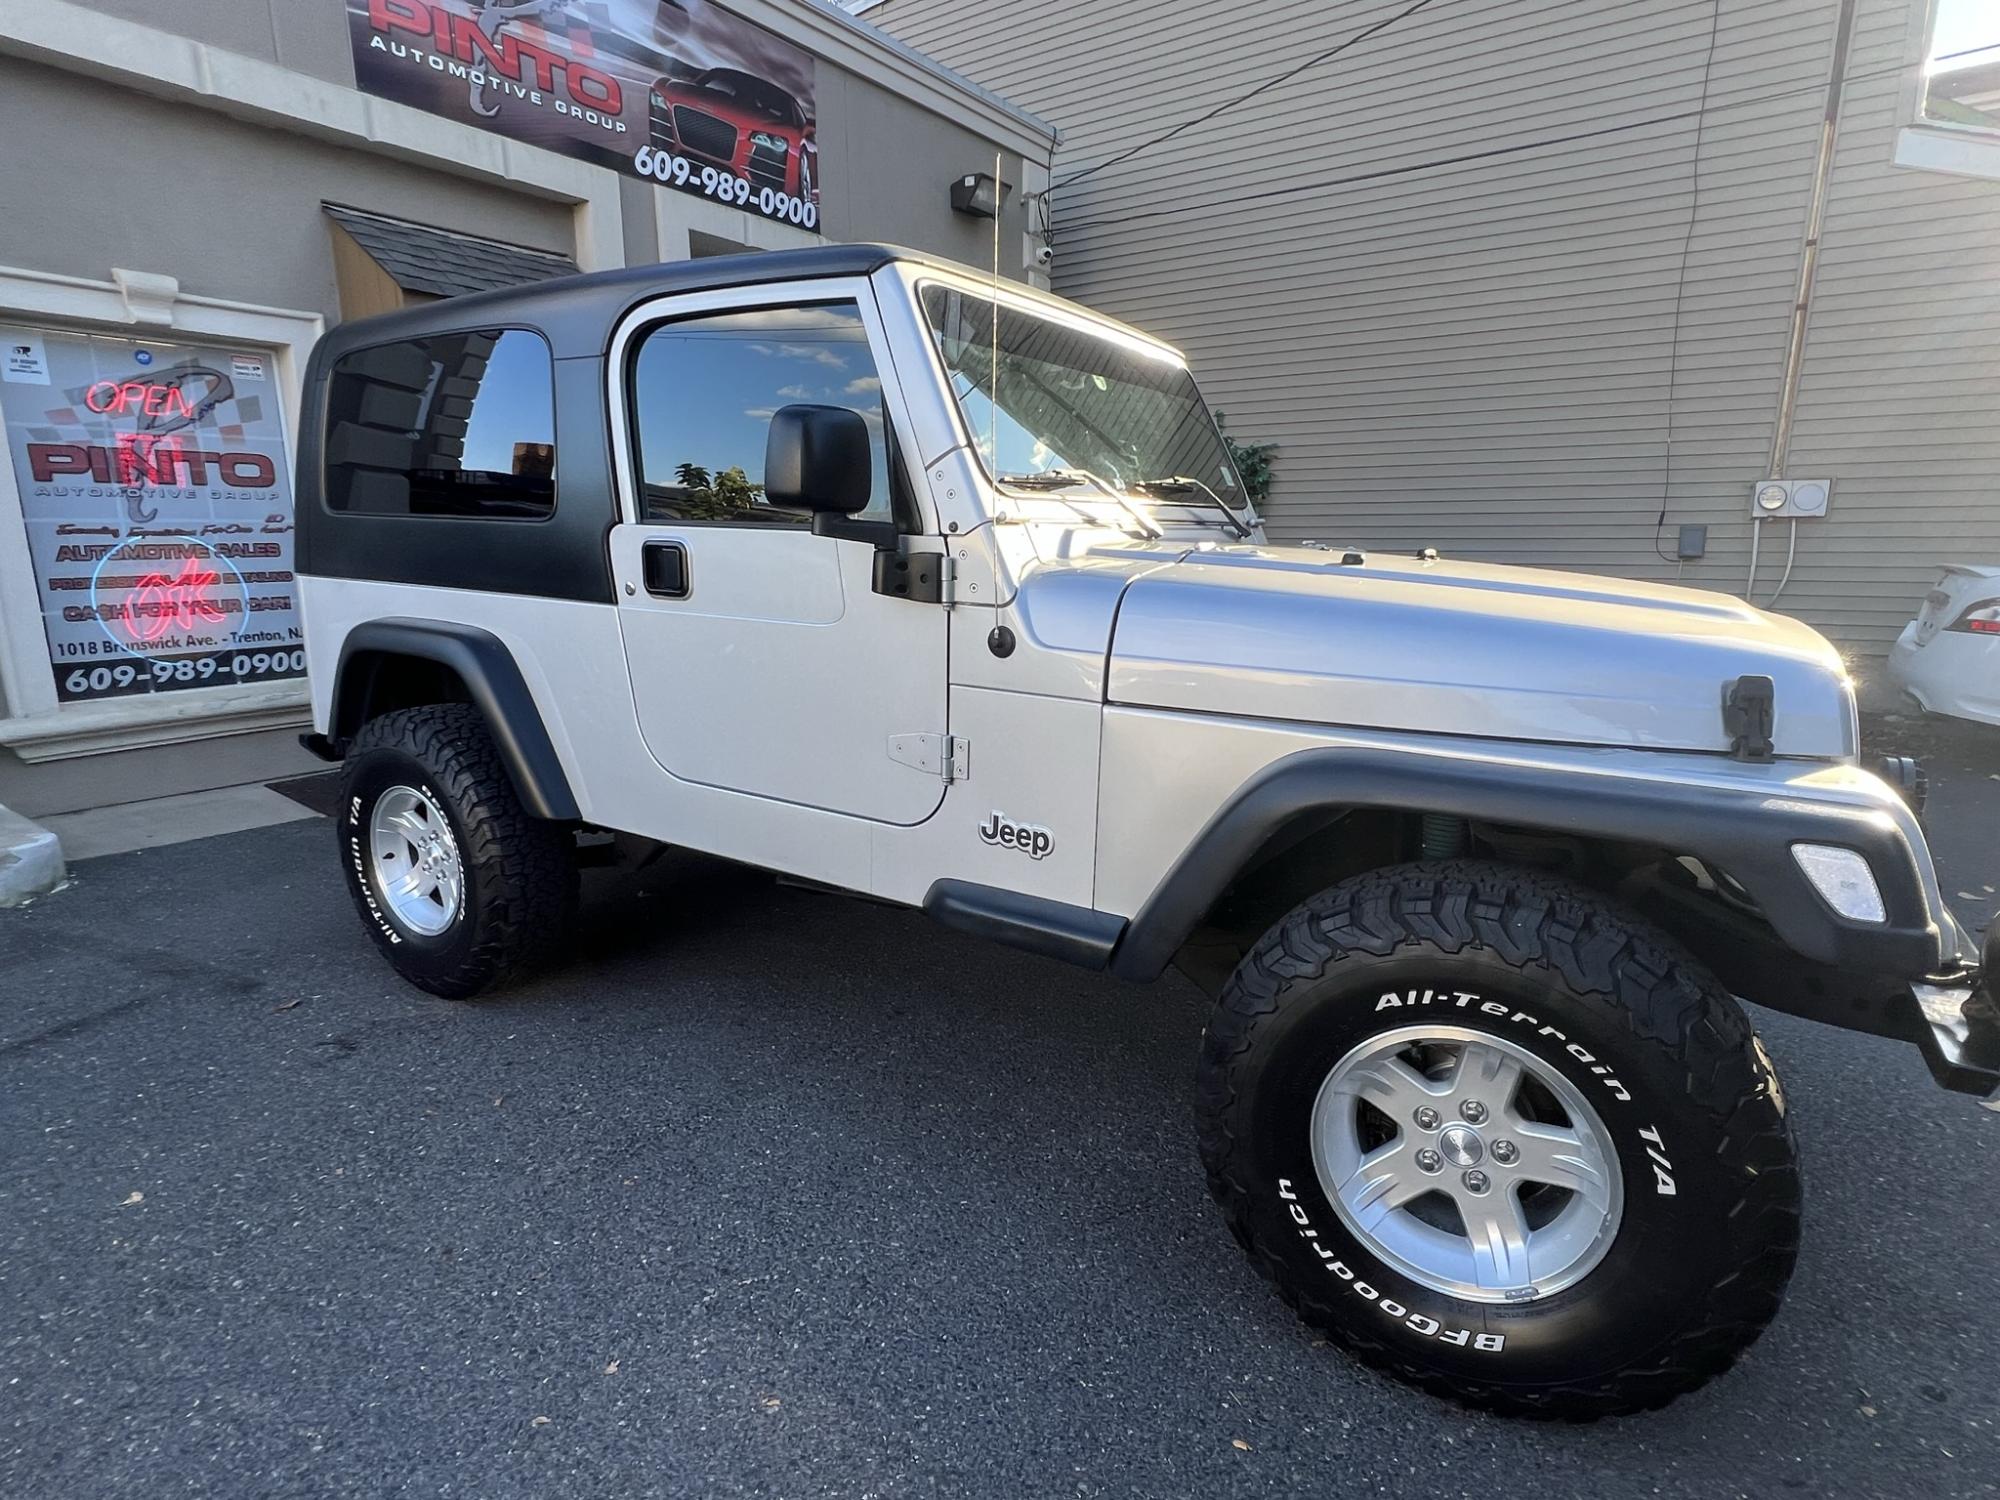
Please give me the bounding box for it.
[1196,862,1800,1420]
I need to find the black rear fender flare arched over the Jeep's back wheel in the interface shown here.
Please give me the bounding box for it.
[328,620,582,822]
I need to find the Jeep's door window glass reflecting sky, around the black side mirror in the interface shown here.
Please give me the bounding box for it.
[632,302,890,526]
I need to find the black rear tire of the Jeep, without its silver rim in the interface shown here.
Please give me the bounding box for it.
[334,704,576,1000]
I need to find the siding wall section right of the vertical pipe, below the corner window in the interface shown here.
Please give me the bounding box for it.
[1782,0,2000,650]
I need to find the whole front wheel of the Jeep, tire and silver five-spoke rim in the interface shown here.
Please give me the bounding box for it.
[1198,864,1798,1420]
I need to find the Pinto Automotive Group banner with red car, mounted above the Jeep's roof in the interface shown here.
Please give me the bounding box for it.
[346,0,820,230]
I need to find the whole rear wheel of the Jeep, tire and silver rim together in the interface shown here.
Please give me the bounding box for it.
[334,704,576,1000]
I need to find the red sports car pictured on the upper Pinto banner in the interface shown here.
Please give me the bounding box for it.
[652,68,820,202]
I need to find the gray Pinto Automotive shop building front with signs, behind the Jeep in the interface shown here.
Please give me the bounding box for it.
[0,0,1054,816]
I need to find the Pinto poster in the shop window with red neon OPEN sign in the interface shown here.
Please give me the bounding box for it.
[0,326,306,702]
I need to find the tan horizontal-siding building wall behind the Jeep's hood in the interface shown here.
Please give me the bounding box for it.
[850,0,2000,676]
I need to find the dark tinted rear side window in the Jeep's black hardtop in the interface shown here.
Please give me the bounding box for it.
[326,328,556,520]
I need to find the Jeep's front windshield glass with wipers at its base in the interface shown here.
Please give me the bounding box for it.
[922,286,1248,510]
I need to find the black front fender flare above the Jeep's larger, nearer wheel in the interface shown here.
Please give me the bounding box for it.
[1110,746,1942,980]
